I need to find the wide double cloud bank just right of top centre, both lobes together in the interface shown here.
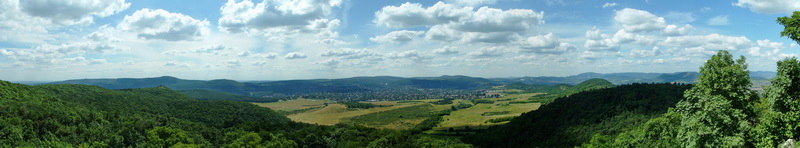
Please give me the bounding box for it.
[374,2,544,43]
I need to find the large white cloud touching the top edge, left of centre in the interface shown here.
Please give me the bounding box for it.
[218,0,342,35]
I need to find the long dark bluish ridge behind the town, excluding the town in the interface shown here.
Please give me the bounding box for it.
[52,76,500,96]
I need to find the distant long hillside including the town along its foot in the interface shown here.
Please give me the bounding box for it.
[51,76,499,102]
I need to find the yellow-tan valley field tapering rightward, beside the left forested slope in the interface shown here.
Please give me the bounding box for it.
[287,103,422,125]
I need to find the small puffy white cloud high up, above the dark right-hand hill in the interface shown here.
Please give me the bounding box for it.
[614,8,666,33]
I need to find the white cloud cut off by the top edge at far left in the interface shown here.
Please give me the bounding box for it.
[19,0,131,25]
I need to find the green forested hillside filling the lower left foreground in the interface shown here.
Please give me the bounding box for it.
[0,81,476,147]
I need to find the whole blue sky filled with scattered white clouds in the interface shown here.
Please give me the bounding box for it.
[0,0,800,81]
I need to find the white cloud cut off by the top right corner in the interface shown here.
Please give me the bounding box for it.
[733,0,800,14]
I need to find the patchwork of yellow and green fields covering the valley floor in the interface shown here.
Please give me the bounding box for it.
[255,93,541,132]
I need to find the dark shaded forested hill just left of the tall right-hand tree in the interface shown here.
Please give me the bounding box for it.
[464,80,691,147]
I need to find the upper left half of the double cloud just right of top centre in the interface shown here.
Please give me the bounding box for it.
[374,2,472,28]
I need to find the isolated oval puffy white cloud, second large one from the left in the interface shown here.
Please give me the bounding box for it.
[117,8,209,41]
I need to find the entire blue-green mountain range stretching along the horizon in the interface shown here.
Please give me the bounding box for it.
[42,71,775,100]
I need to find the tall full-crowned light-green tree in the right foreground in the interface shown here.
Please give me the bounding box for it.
[677,51,758,147]
